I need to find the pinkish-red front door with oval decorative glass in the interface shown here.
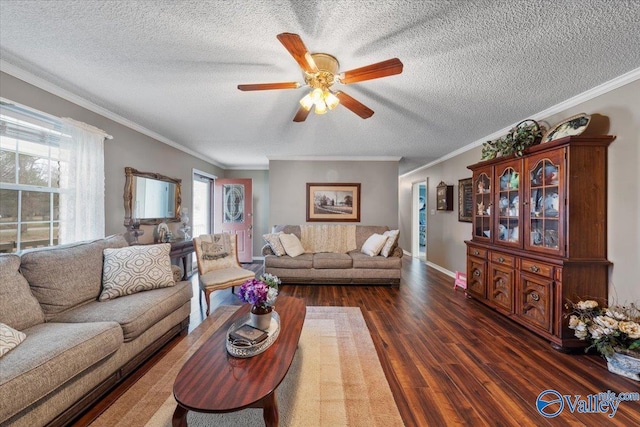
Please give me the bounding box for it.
[214,178,253,263]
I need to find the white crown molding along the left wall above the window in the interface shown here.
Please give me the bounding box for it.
[0,59,228,169]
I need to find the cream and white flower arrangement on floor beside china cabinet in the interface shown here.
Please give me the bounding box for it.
[566,300,640,358]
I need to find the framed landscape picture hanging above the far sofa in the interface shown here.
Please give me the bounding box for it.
[307,183,360,222]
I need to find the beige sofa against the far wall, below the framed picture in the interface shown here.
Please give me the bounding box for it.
[262,225,403,285]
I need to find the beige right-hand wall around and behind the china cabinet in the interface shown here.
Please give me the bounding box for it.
[399,80,640,303]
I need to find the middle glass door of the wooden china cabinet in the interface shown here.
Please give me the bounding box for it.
[493,160,522,246]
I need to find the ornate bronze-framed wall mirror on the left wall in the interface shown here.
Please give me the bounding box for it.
[124,167,182,227]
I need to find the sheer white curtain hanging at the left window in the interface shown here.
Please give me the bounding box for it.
[60,118,108,243]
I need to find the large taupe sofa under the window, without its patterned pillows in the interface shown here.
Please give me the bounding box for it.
[0,235,193,427]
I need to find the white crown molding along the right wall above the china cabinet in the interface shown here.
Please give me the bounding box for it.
[400,68,640,178]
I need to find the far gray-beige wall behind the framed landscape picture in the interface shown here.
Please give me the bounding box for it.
[269,160,398,228]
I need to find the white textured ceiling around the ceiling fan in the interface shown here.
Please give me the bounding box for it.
[0,0,640,172]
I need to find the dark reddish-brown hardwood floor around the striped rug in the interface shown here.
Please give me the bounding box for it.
[77,256,640,426]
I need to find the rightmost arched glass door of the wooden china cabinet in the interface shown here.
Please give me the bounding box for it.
[525,151,565,255]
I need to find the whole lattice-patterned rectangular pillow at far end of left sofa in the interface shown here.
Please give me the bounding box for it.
[98,243,175,301]
